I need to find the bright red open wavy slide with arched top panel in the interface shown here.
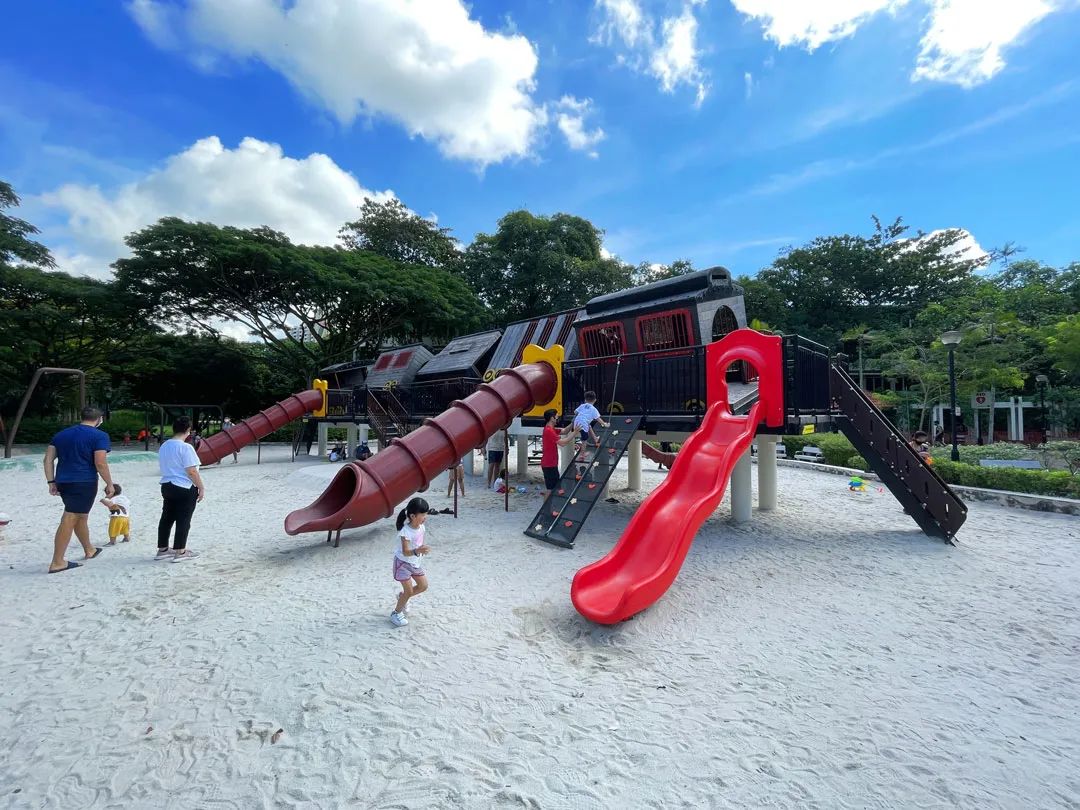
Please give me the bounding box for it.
[570,329,783,624]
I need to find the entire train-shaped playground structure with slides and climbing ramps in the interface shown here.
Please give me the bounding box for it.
[113,268,967,623]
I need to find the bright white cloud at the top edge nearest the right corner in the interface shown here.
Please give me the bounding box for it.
[912,0,1059,87]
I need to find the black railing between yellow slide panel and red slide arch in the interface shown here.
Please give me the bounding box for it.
[563,346,705,420]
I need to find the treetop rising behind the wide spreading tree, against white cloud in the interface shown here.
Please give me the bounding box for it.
[338,199,461,270]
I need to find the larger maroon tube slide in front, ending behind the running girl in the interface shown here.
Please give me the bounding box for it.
[285,362,558,535]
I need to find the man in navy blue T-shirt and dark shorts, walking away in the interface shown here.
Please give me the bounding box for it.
[45,407,113,573]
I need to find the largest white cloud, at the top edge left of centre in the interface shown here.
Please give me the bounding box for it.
[129,0,548,165]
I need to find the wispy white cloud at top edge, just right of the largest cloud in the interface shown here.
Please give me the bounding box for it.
[591,0,708,105]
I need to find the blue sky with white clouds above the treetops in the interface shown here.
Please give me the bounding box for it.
[0,0,1080,275]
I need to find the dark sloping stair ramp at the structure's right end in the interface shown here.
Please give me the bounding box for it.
[829,363,968,544]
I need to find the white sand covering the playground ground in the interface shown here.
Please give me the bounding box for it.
[0,448,1080,810]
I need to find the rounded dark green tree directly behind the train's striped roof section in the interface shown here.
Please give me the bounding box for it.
[464,211,634,324]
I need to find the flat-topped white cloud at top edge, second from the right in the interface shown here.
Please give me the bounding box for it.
[731,0,907,51]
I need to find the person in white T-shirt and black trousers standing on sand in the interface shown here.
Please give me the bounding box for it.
[154,416,206,563]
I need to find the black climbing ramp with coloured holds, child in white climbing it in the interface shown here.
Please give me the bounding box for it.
[525,416,643,549]
